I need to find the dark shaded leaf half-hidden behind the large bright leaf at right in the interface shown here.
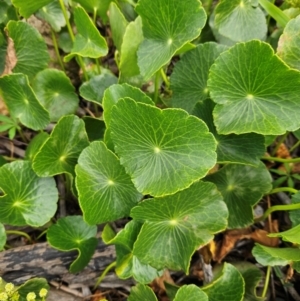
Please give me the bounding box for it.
[170,42,227,112]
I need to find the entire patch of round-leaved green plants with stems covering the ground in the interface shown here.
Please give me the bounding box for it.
[0,0,300,301]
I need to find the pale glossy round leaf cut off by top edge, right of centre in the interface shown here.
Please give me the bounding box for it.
[215,0,268,42]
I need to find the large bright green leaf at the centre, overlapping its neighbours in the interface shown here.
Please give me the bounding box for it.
[110,99,216,196]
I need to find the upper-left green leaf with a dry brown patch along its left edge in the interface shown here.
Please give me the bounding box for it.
[7,21,50,80]
